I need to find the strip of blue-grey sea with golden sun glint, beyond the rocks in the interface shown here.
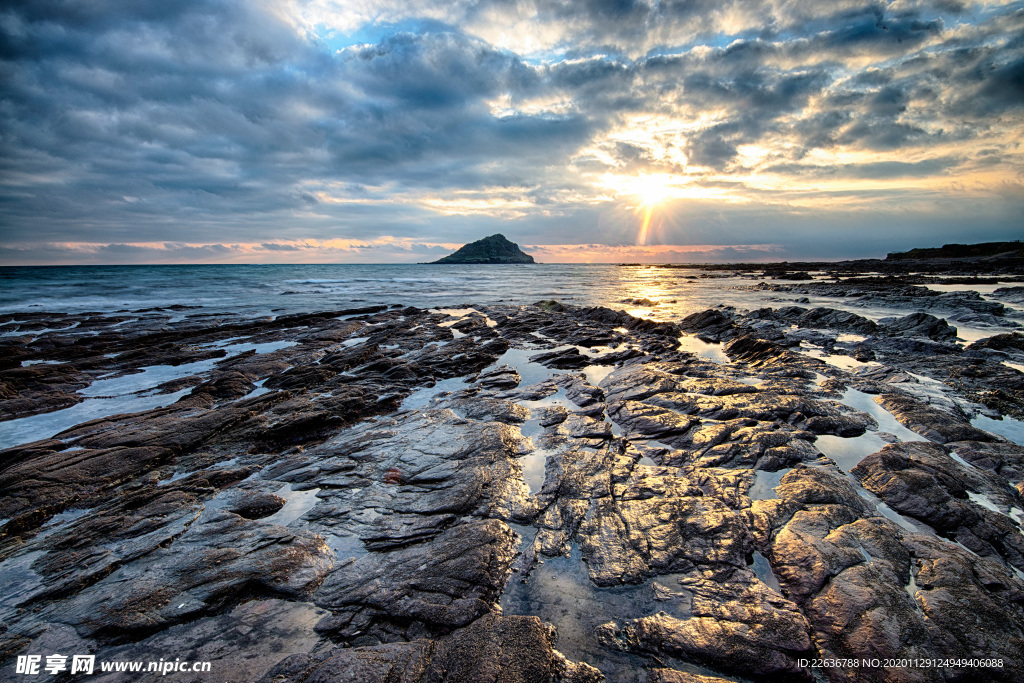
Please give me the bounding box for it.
[0,263,1019,341]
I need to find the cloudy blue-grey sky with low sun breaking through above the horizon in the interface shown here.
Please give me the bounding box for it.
[0,0,1024,265]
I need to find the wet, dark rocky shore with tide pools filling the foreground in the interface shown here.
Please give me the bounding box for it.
[0,270,1024,683]
